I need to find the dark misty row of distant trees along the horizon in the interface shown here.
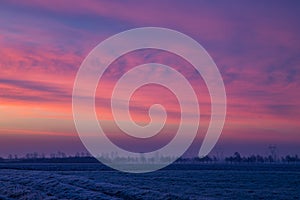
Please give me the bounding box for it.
[0,151,300,164]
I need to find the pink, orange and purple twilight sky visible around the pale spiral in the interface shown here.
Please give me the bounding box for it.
[0,0,300,157]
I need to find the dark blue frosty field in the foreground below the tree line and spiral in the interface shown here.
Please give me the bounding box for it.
[0,163,300,200]
